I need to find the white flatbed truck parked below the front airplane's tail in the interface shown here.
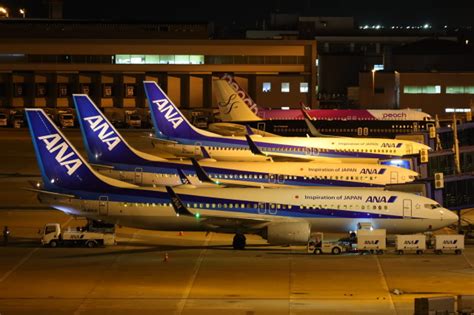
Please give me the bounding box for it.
[41,223,115,248]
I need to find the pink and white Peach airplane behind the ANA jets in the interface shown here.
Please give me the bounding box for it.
[217,74,434,138]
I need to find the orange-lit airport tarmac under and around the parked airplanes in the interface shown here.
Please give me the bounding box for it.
[0,129,474,315]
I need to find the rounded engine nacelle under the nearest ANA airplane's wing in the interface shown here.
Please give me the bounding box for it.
[263,222,311,245]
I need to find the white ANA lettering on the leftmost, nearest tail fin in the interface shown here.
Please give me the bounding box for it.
[38,133,82,176]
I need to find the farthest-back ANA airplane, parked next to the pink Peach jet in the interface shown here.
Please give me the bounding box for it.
[144,81,430,161]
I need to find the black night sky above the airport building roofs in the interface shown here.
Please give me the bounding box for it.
[0,0,474,25]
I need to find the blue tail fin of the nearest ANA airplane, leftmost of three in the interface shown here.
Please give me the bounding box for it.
[25,109,131,191]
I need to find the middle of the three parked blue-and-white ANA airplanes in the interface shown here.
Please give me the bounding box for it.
[73,94,418,187]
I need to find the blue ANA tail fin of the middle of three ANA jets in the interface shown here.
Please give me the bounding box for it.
[73,94,140,164]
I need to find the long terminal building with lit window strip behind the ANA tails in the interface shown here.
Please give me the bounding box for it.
[0,19,317,116]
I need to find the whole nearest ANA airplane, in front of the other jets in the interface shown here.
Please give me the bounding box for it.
[25,108,458,249]
